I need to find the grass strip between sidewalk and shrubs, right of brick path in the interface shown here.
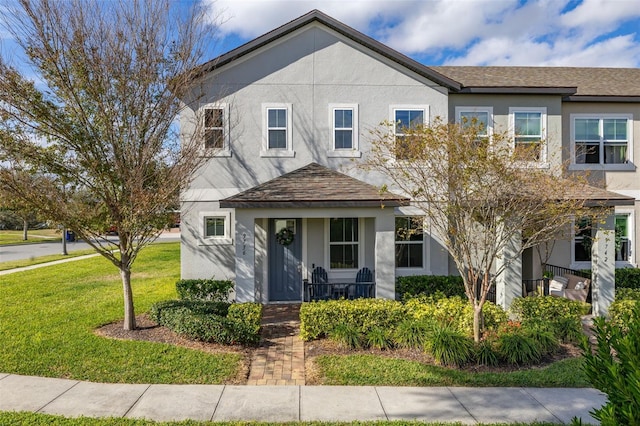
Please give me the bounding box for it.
[316,355,591,387]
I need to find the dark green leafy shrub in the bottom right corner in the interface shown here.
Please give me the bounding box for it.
[582,306,640,425]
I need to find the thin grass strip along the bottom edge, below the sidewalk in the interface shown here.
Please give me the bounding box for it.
[0,412,557,426]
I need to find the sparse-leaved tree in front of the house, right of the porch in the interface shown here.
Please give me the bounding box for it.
[362,119,593,341]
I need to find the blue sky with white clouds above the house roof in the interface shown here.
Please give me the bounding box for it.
[204,0,640,67]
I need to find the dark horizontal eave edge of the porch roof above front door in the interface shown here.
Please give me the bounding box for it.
[220,199,410,209]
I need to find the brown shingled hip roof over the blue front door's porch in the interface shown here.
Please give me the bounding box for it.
[220,163,410,208]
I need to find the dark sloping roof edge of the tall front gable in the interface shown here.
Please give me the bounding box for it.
[189,10,460,90]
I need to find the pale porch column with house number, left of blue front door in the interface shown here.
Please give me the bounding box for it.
[234,209,256,302]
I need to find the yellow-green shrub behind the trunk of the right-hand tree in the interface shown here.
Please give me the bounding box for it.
[405,296,507,335]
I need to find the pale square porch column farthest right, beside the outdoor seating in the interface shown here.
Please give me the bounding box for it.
[591,208,616,316]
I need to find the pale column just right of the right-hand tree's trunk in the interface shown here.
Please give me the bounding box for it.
[495,226,522,310]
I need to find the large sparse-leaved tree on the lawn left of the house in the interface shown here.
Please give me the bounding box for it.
[0,0,216,330]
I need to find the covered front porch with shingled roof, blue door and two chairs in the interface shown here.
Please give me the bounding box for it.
[220,163,409,303]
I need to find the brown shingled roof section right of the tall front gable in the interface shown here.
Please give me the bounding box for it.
[431,66,640,102]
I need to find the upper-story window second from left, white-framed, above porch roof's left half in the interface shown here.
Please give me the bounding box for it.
[260,104,295,157]
